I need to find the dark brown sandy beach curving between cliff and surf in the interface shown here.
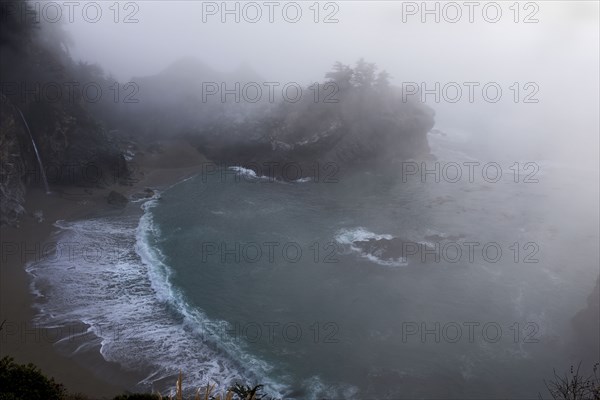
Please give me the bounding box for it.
[0,141,207,398]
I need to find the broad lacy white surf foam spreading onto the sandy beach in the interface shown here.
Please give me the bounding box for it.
[27,200,287,395]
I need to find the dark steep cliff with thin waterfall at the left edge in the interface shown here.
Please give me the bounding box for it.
[0,3,128,224]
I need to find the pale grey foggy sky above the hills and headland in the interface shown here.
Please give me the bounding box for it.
[41,0,600,163]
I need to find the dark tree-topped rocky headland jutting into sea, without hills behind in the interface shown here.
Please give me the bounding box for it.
[190,86,435,178]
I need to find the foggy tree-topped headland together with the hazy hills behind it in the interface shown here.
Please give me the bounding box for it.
[129,59,434,176]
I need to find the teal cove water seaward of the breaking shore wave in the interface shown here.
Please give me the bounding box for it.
[144,134,598,398]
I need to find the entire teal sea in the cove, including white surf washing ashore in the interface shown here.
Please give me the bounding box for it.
[28,131,599,398]
